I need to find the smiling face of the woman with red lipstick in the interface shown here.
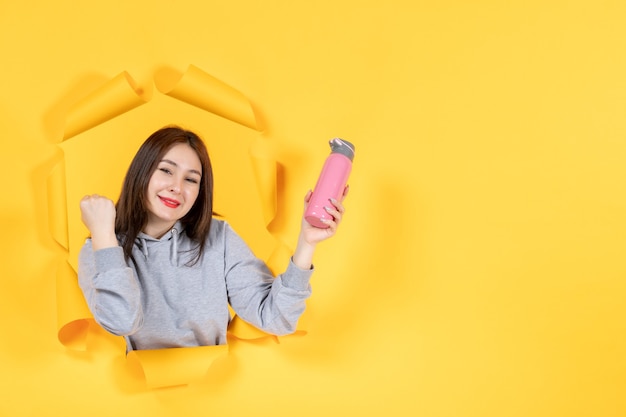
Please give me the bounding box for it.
[143,143,202,238]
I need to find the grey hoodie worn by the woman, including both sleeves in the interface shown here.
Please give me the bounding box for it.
[78,219,313,350]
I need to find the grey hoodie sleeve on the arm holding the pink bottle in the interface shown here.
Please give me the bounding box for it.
[224,223,313,336]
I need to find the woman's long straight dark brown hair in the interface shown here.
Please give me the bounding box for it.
[115,126,213,264]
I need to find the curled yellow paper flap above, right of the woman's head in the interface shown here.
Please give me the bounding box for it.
[154,65,258,130]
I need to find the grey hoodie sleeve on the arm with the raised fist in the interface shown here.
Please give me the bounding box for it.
[78,239,143,336]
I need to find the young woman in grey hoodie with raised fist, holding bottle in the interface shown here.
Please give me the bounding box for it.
[78,127,345,350]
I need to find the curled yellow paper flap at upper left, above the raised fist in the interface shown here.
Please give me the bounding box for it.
[63,71,146,140]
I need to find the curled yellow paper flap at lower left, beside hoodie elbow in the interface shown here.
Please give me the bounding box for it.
[57,262,93,350]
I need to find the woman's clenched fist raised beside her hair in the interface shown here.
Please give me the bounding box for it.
[80,194,118,250]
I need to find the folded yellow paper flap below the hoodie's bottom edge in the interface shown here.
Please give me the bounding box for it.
[127,345,228,388]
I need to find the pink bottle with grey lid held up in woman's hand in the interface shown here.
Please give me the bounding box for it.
[304,138,354,229]
